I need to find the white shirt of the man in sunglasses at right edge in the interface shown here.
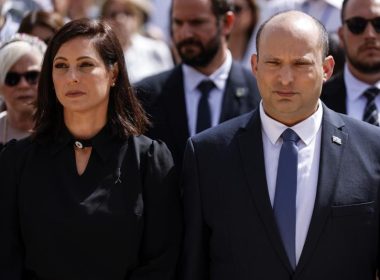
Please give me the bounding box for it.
[343,64,380,120]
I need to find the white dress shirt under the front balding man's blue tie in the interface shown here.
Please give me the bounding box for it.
[260,101,323,263]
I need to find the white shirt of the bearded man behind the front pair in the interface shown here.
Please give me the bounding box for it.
[182,51,232,136]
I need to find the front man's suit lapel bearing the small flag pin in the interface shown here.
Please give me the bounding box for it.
[296,105,348,274]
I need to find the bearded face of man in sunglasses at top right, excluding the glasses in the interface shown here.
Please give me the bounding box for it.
[339,0,380,74]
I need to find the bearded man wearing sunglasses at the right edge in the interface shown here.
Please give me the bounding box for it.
[322,0,380,126]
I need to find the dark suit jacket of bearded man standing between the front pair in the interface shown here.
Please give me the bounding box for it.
[136,62,260,166]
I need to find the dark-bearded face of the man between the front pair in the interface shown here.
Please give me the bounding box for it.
[172,0,223,67]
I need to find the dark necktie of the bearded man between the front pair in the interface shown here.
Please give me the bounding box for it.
[196,80,215,133]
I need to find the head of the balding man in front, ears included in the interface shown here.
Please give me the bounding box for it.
[252,16,334,126]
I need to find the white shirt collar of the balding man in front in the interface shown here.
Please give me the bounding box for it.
[260,100,323,146]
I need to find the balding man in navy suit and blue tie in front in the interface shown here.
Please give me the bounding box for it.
[181,11,380,280]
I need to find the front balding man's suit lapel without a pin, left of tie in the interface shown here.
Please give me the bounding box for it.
[238,110,292,271]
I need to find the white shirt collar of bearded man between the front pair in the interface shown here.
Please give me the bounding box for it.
[182,50,232,91]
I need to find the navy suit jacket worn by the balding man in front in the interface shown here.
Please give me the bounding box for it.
[183,106,380,280]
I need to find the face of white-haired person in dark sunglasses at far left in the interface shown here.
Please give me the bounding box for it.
[0,54,42,114]
